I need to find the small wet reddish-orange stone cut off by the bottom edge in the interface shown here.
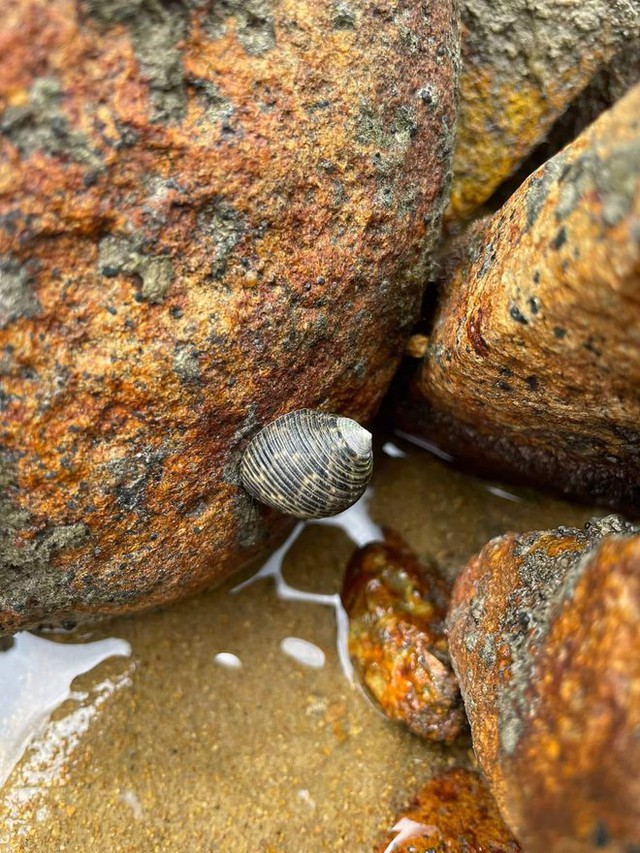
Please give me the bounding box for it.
[375,768,520,853]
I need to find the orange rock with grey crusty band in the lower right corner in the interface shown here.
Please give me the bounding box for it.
[447,516,640,853]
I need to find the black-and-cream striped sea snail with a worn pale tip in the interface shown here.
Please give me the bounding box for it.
[240,409,373,518]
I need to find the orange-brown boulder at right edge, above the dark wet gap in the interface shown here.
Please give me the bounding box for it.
[400,86,640,510]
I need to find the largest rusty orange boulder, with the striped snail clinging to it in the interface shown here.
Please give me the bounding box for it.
[0,0,458,631]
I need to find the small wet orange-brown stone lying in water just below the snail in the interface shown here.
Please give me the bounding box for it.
[342,534,465,743]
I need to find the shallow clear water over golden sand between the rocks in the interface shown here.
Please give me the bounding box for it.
[0,437,602,853]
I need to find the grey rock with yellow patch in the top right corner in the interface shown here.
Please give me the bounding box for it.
[447,0,640,219]
